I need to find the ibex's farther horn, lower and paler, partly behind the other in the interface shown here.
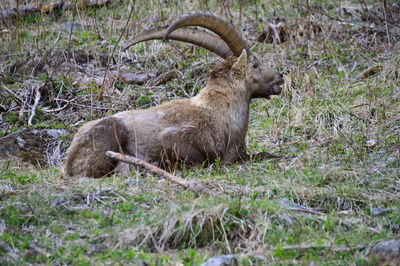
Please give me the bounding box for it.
[123,27,232,59]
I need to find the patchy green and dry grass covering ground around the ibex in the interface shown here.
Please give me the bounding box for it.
[0,1,400,265]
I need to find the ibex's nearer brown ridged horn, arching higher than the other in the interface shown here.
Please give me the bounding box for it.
[164,13,248,56]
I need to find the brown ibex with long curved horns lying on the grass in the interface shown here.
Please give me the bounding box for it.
[63,13,283,177]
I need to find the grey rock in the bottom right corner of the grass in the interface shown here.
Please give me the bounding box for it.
[368,239,400,265]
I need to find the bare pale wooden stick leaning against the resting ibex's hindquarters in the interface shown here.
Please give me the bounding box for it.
[106,151,227,199]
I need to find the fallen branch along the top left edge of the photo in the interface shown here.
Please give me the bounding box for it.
[0,0,111,21]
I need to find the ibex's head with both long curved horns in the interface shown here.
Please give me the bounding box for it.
[127,13,283,98]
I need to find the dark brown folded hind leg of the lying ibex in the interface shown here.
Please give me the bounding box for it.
[64,117,128,178]
